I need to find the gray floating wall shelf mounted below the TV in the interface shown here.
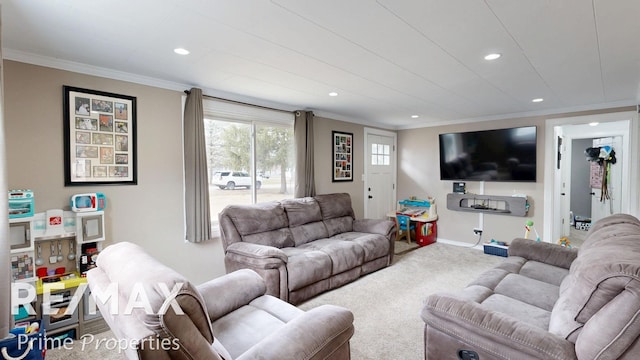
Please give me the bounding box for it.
[447,193,529,216]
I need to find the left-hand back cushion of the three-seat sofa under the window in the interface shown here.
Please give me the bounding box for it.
[218,202,294,249]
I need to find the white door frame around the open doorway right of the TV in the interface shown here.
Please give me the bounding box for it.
[543,111,640,242]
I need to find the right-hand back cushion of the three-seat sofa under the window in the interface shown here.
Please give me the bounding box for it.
[315,193,355,236]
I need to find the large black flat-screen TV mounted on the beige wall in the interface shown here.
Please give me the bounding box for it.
[439,126,536,182]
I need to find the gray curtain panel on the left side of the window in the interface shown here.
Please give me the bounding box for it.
[184,88,211,243]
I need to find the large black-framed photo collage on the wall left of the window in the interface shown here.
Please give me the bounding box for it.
[63,85,138,186]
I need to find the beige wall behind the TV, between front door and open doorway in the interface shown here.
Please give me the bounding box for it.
[398,118,544,244]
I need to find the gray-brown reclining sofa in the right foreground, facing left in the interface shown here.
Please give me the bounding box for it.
[421,214,640,360]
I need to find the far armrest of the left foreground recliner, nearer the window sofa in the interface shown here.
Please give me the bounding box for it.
[196,269,267,321]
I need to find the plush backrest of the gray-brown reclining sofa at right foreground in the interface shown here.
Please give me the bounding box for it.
[549,214,640,358]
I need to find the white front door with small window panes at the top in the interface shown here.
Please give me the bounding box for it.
[364,128,396,219]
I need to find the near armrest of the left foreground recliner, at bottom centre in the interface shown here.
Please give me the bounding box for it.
[237,305,354,360]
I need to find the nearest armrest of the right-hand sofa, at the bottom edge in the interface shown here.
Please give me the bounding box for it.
[420,294,576,360]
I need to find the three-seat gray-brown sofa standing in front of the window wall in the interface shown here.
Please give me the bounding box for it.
[219,193,396,304]
